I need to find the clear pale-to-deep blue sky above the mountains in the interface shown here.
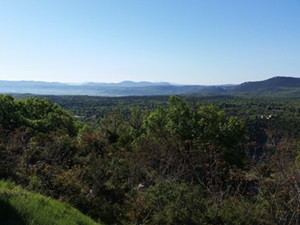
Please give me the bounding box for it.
[0,0,300,84]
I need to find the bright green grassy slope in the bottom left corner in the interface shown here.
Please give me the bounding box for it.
[0,181,101,225]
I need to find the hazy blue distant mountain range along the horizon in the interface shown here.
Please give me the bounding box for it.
[0,77,300,96]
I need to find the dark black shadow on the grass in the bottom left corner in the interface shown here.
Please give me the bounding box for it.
[0,200,26,225]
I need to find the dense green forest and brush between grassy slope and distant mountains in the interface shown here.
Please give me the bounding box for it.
[0,94,300,225]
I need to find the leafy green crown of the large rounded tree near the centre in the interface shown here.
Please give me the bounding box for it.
[140,96,245,181]
